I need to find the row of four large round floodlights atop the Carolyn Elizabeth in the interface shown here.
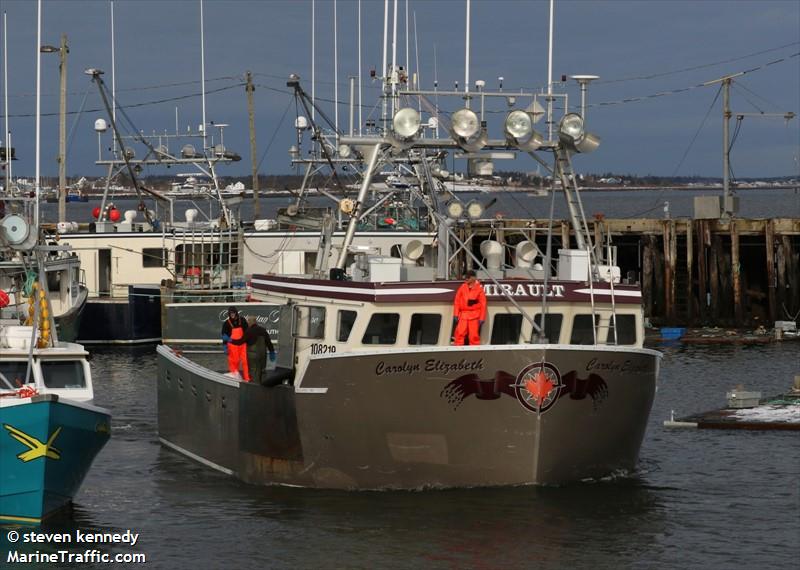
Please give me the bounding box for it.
[391,107,600,153]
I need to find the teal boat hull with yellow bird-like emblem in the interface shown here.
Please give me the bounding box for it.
[0,395,111,524]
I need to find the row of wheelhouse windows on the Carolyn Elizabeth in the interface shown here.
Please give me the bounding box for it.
[295,306,636,346]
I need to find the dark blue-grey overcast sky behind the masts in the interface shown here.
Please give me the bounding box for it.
[0,0,800,177]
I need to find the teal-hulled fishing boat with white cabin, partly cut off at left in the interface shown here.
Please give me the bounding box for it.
[0,205,111,524]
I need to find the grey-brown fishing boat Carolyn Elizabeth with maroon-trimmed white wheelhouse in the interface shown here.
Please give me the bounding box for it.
[157,1,660,489]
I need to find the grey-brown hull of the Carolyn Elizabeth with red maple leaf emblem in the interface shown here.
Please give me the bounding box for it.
[158,345,660,489]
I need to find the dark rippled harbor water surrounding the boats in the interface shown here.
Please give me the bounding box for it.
[0,342,800,569]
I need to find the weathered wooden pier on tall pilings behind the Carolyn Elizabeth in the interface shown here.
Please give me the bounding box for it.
[457,214,800,328]
